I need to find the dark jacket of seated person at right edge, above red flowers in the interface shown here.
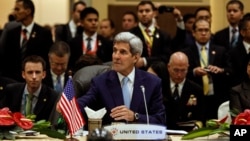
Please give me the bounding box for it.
[229,79,250,112]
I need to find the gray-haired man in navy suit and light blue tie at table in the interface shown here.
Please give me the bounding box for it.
[57,32,165,125]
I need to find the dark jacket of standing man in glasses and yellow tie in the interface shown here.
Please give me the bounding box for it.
[183,43,231,117]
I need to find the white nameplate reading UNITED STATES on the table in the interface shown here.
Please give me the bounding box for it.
[104,124,166,140]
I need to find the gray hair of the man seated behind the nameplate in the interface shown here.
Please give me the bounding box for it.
[114,32,143,56]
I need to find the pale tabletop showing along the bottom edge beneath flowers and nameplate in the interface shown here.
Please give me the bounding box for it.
[4,134,229,141]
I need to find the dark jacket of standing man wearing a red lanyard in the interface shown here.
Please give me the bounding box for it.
[69,34,113,69]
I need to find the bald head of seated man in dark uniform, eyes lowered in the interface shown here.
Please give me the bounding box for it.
[168,52,189,84]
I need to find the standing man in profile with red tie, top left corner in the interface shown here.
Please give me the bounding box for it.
[1,0,53,81]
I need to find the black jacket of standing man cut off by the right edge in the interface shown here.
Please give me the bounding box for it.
[228,41,249,86]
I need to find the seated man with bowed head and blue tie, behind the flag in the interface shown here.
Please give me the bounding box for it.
[43,41,70,131]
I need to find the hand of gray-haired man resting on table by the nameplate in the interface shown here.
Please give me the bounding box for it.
[110,105,135,121]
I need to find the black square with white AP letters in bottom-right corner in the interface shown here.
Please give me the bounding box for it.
[230,125,250,141]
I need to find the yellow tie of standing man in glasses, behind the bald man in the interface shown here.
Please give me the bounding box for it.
[201,46,209,95]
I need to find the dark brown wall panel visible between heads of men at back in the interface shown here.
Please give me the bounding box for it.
[108,5,209,37]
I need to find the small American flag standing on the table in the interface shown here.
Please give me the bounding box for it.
[59,77,85,135]
